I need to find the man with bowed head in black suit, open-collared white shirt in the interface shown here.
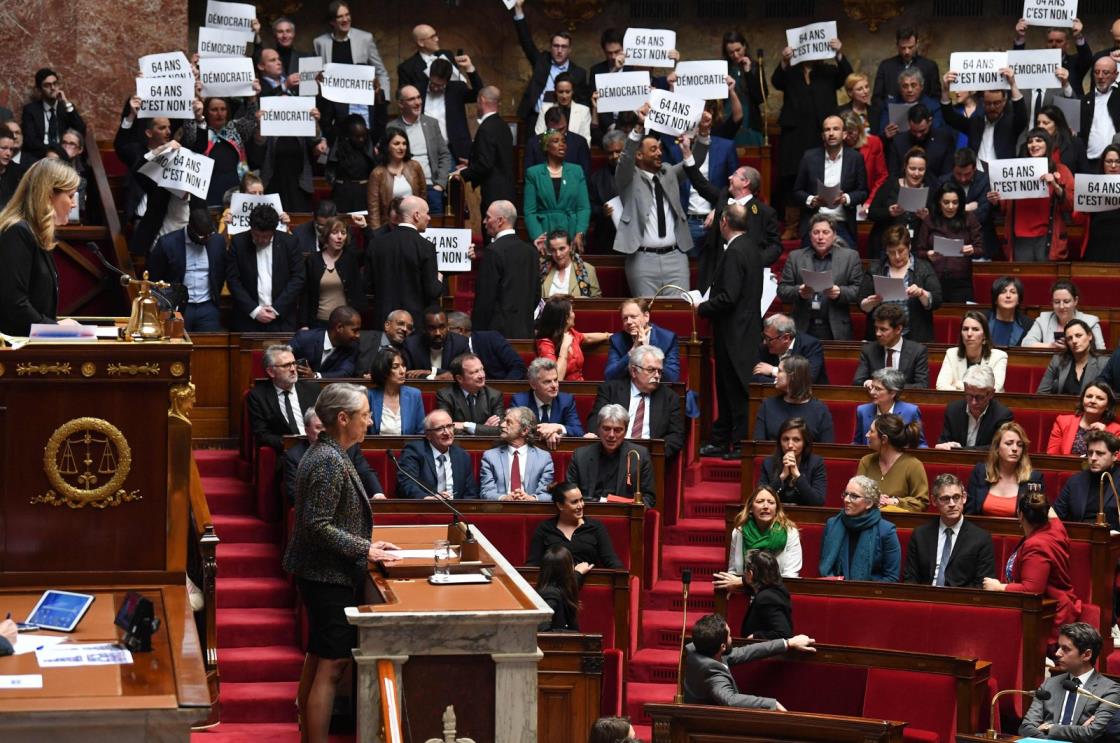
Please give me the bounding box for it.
[225,204,306,333]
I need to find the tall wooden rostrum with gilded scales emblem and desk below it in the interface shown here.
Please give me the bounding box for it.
[0,333,211,743]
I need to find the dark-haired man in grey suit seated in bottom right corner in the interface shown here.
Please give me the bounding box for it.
[1019,622,1120,741]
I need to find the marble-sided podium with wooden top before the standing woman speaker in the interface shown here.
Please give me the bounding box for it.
[346,526,552,743]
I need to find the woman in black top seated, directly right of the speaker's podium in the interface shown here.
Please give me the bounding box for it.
[525,482,625,575]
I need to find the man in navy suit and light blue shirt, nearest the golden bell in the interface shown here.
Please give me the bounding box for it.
[148,208,225,333]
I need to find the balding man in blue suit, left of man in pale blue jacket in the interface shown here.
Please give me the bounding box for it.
[396,410,478,500]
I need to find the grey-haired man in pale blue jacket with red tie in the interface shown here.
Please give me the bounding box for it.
[478,408,552,501]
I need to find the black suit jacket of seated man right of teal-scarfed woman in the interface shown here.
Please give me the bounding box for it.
[903,519,996,588]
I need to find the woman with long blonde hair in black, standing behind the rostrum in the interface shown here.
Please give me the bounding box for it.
[0,158,81,335]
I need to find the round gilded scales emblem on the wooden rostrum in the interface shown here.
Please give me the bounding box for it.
[31,418,142,509]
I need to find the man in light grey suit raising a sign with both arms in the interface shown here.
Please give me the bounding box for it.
[615,103,708,297]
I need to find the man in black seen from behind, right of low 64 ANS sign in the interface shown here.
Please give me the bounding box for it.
[472,201,541,336]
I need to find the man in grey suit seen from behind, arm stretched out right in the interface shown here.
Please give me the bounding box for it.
[684,614,816,712]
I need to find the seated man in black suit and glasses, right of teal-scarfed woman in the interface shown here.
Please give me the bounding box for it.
[903,473,996,588]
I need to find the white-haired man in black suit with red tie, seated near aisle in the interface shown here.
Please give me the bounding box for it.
[587,345,684,458]
